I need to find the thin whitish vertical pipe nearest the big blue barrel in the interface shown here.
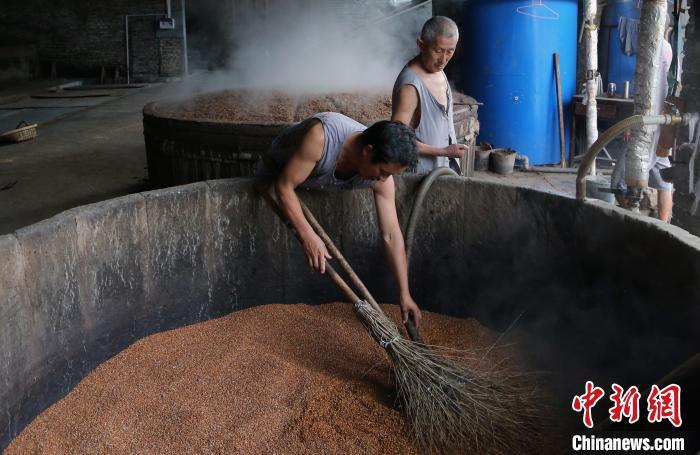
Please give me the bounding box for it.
[583,0,598,175]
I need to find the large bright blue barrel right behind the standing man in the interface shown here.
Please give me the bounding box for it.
[460,0,577,164]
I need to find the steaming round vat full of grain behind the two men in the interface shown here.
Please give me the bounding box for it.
[143,90,479,188]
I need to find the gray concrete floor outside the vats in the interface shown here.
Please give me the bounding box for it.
[0,76,575,235]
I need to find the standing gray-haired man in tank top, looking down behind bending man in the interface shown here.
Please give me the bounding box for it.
[391,16,467,174]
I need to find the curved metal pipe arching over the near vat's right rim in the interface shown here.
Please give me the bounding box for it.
[576,114,691,201]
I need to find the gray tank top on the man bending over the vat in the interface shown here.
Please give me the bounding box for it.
[260,112,377,191]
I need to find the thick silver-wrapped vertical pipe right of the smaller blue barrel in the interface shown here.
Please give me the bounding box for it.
[625,0,666,194]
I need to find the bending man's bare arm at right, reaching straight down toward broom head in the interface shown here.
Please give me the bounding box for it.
[372,177,421,327]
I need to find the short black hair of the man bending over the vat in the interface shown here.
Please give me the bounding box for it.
[362,120,418,168]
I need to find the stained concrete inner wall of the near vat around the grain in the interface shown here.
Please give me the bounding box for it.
[0,177,700,447]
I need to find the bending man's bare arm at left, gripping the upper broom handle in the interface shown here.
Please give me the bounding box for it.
[275,122,331,273]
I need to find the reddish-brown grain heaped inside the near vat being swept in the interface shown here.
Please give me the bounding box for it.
[6,304,548,455]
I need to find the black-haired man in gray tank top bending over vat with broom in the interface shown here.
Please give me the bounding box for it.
[260,112,421,326]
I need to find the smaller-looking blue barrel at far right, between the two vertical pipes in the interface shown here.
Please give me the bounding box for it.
[599,0,641,93]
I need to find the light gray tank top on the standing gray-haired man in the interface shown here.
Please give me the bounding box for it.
[391,65,456,174]
